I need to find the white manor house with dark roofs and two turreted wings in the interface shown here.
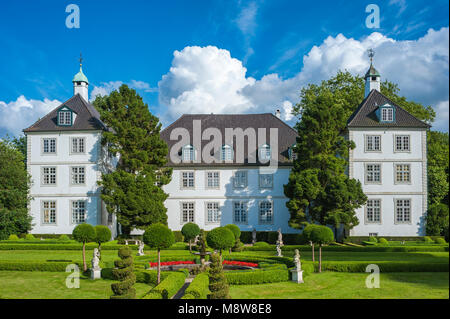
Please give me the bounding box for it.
[24,60,429,240]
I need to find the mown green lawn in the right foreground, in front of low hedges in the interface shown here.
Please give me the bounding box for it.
[230,272,449,299]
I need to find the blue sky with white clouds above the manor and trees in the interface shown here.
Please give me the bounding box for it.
[0,0,449,136]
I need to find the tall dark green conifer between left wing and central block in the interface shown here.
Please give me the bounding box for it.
[94,85,172,234]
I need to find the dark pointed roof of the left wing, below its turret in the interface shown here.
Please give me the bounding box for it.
[23,94,106,133]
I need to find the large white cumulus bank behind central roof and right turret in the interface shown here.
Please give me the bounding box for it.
[158,28,449,129]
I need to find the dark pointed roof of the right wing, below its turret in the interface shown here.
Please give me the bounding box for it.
[347,90,431,128]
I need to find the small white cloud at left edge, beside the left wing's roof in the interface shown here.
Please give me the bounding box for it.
[0,95,61,136]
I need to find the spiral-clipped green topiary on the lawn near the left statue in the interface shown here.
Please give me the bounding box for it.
[111,247,136,299]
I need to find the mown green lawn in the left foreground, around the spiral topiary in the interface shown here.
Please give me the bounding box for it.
[0,271,152,299]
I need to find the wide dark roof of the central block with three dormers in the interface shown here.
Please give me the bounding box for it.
[161,113,298,166]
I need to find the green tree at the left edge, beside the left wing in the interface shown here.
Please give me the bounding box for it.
[0,139,32,239]
